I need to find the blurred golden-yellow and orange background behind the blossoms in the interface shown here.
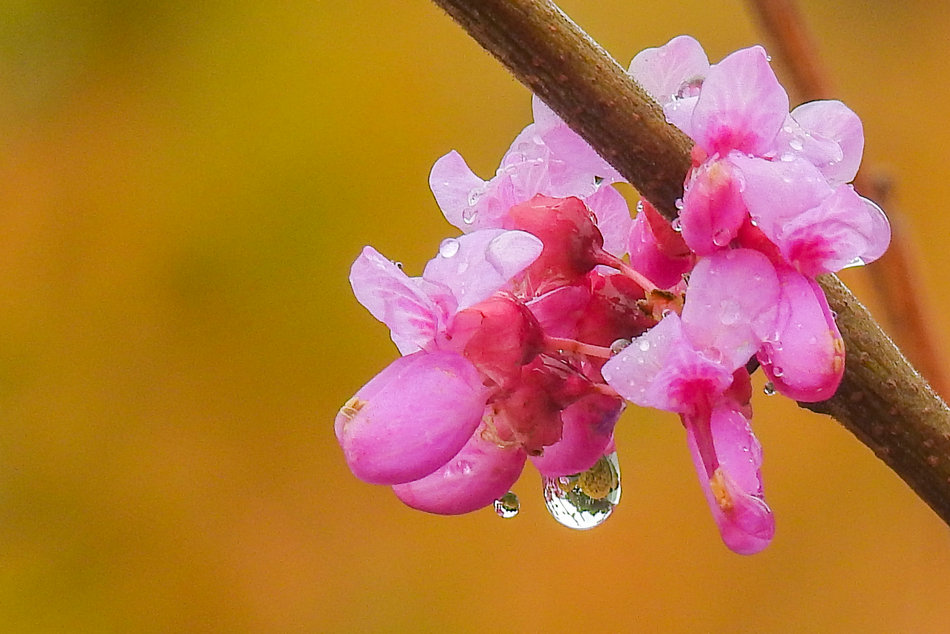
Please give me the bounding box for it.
[0,0,950,632]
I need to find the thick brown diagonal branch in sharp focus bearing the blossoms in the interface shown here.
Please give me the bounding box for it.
[434,0,950,523]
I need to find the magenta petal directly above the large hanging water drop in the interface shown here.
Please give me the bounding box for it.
[531,394,624,478]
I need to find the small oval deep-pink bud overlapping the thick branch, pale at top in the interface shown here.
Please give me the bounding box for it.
[680,161,748,255]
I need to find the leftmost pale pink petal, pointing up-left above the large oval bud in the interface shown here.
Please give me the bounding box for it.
[350,247,441,354]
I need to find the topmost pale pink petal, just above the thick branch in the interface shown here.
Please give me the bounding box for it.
[628,35,709,105]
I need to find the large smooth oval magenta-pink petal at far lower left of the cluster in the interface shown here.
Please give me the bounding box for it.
[334,352,486,484]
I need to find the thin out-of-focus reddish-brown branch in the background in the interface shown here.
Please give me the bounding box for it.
[749,0,950,394]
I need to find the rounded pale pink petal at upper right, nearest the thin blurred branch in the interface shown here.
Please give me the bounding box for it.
[791,100,864,184]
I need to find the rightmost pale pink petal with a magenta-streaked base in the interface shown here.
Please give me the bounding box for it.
[775,180,891,277]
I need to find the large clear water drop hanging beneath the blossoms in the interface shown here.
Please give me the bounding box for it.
[543,451,620,530]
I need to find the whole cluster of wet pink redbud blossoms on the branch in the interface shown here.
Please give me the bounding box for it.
[335,36,890,553]
